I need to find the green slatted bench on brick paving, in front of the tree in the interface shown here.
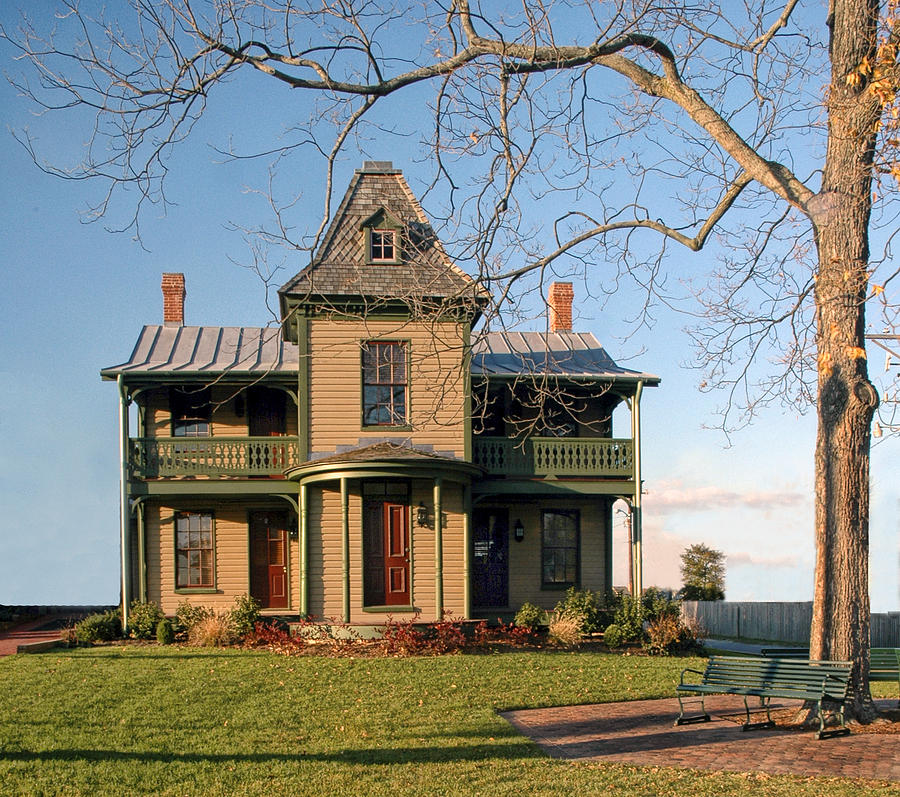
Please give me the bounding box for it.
[675,656,851,739]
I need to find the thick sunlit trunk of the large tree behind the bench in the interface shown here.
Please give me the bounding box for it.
[809,0,881,721]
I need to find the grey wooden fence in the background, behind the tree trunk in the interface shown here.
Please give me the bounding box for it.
[681,601,900,648]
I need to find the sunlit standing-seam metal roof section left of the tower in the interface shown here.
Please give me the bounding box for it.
[100,324,300,379]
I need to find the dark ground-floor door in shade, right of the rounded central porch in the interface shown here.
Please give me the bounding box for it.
[472,509,509,607]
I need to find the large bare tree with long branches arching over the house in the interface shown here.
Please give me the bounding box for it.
[3,0,898,719]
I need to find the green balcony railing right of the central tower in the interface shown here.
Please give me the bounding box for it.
[472,437,634,479]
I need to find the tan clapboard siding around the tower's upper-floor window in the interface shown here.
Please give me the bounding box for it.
[309,319,465,457]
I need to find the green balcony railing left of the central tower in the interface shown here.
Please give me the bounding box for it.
[131,437,299,479]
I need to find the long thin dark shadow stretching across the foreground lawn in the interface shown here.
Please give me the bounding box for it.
[0,740,545,765]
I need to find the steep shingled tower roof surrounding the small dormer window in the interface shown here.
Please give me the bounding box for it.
[279,161,487,310]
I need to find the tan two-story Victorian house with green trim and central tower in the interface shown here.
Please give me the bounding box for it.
[101,161,659,625]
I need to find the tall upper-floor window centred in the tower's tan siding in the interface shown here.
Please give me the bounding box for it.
[362,341,407,426]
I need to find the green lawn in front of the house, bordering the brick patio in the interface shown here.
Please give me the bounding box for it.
[0,646,900,797]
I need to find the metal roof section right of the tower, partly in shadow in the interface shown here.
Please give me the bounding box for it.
[472,332,659,385]
